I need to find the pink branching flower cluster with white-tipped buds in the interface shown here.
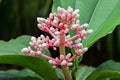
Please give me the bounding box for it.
[22,7,93,67]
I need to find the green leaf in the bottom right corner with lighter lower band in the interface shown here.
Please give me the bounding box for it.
[87,60,120,80]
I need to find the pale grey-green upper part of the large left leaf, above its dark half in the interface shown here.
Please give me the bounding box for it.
[0,35,31,55]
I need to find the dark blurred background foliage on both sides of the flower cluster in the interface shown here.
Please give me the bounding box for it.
[0,0,120,66]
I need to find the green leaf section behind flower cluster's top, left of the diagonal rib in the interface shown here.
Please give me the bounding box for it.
[52,0,98,23]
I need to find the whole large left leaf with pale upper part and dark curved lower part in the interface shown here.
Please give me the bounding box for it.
[0,36,57,80]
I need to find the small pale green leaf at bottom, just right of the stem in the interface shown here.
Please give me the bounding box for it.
[76,66,94,80]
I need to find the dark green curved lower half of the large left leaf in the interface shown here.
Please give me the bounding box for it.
[0,55,57,80]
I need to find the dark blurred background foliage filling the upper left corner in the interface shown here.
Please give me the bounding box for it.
[0,0,52,40]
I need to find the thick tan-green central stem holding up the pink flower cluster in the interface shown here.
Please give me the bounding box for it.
[59,35,72,80]
